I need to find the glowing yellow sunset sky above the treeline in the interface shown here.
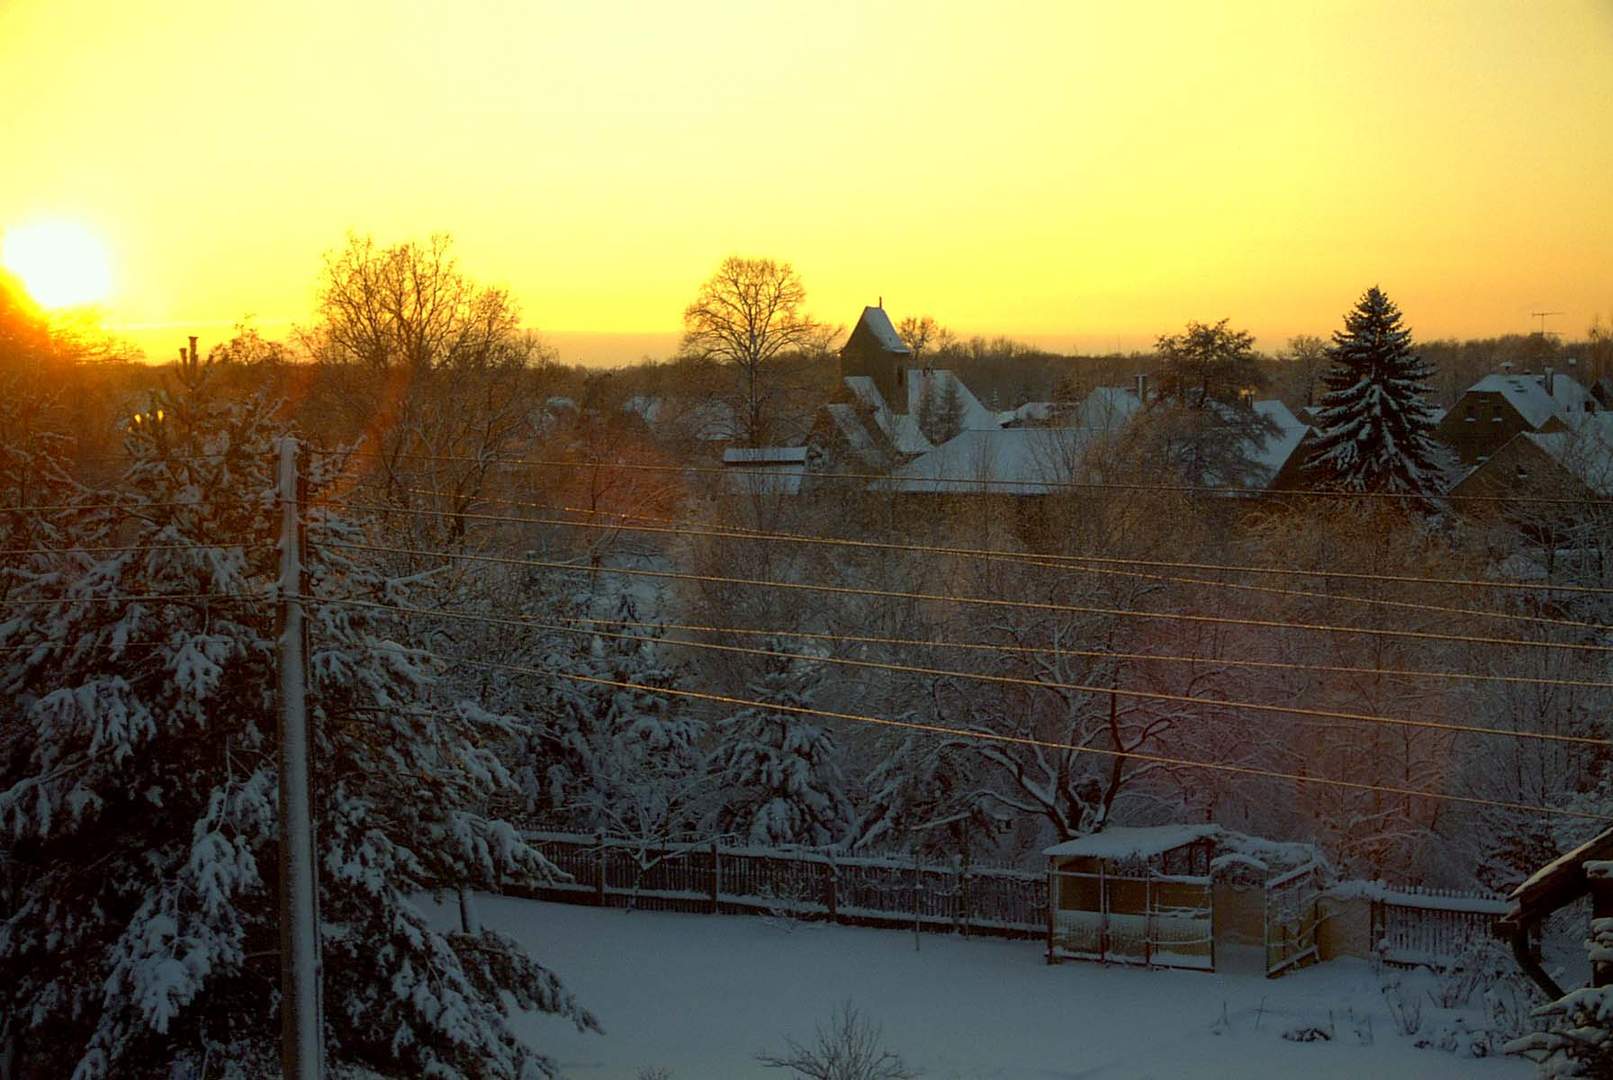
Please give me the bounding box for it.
[0,0,1613,361]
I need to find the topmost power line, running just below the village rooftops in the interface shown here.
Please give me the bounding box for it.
[315,444,1613,506]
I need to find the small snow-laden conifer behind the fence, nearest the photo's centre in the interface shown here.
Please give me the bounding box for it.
[715,646,852,846]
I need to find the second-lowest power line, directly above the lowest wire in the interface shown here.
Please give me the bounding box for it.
[327,600,1613,748]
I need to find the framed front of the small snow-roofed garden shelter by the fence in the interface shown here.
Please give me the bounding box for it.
[1047,870,1215,970]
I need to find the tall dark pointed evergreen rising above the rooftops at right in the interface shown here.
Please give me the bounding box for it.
[1307,285,1439,495]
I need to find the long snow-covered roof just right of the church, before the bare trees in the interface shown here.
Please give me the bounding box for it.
[874,427,1095,495]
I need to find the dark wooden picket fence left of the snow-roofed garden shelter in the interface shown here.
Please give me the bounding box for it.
[509,832,1047,937]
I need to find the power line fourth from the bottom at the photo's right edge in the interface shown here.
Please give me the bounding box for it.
[326,540,1613,653]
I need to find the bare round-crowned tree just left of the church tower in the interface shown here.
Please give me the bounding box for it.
[682,255,823,445]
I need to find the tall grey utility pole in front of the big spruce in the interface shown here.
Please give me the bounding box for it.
[279,435,324,1080]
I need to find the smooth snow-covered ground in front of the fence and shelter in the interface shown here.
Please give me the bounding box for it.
[461,896,1532,1080]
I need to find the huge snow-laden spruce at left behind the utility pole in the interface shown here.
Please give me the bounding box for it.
[0,376,595,1080]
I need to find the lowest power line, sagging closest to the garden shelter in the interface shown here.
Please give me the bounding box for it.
[400,653,1613,822]
